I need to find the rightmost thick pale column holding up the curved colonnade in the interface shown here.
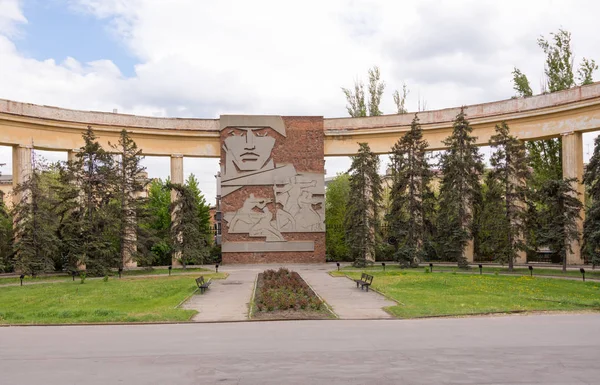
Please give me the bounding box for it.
[562,132,585,265]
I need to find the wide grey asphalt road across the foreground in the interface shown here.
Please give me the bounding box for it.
[0,314,600,385]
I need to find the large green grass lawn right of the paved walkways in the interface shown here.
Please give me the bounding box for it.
[332,270,600,318]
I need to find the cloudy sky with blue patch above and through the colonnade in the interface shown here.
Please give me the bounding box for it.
[0,0,600,202]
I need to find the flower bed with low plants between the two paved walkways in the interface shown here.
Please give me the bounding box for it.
[253,268,331,319]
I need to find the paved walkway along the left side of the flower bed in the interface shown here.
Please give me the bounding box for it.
[182,266,261,322]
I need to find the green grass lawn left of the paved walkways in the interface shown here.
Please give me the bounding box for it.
[0,273,226,324]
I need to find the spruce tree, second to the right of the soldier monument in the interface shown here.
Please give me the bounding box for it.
[387,114,432,266]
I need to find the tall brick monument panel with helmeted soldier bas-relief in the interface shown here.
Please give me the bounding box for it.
[220,115,325,263]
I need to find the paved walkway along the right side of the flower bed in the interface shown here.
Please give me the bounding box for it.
[299,268,396,319]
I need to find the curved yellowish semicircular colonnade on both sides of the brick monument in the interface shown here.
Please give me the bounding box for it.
[0,82,600,263]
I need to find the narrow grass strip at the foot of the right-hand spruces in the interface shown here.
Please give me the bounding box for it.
[343,262,600,279]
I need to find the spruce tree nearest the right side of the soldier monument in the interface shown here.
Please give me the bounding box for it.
[345,143,382,266]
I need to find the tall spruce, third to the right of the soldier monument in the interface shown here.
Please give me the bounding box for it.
[438,109,483,267]
